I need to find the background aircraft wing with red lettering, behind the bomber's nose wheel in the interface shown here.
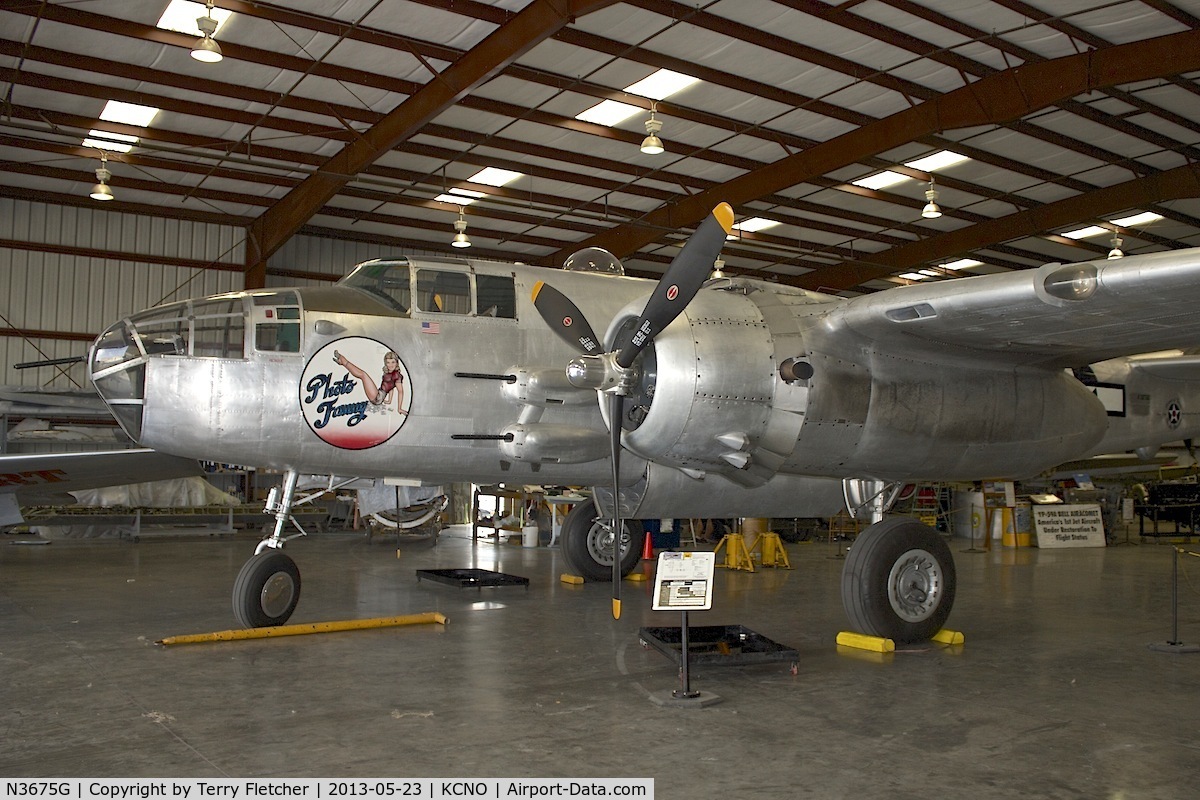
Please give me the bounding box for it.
[0,450,200,505]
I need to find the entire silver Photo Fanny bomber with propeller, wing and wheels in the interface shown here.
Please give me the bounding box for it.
[58,204,1200,642]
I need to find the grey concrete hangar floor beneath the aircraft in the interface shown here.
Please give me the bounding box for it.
[0,528,1200,800]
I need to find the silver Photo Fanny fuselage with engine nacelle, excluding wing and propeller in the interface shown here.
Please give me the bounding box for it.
[91,259,1198,517]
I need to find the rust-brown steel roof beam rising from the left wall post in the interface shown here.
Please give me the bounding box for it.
[246,0,616,289]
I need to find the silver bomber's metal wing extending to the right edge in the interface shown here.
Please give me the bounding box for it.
[824,249,1200,367]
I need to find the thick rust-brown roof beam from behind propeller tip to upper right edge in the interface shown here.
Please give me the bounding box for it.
[566,30,1200,263]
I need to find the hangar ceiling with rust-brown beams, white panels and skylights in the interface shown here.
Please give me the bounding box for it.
[0,0,1200,293]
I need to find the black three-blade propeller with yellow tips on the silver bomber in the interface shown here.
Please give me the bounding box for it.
[533,203,733,619]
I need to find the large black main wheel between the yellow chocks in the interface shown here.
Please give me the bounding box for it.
[841,517,956,643]
